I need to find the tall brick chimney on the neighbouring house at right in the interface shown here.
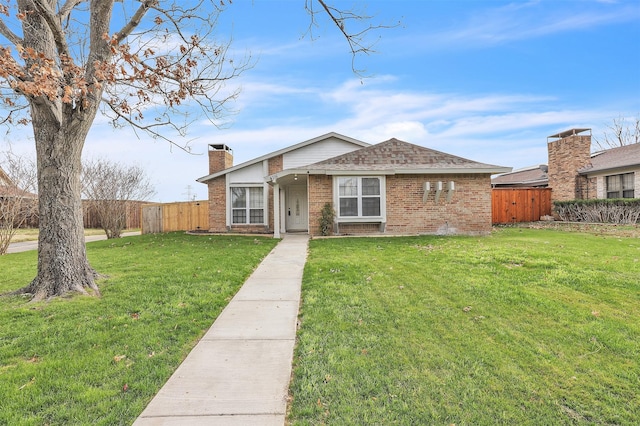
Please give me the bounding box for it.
[547,129,591,201]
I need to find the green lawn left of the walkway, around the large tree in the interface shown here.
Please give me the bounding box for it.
[0,233,277,425]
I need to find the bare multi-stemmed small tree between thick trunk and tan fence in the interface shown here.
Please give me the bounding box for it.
[82,159,155,239]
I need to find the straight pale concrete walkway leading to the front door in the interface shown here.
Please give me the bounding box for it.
[134,234,309,426]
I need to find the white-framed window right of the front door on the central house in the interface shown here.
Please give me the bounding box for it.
[337,176,382,218]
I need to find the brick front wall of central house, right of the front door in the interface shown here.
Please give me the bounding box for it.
[309,175,491,240]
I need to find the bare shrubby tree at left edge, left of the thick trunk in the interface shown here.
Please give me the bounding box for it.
[0,151,38,255]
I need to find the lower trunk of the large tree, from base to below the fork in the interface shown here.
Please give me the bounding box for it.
[25,107,100,300]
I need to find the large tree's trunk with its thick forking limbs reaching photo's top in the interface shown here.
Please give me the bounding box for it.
[12,0,113,300]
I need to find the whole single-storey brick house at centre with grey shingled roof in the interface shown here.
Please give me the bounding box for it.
[198,133,510,237]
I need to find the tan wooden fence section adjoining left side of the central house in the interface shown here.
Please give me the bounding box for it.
[141,201,209,234]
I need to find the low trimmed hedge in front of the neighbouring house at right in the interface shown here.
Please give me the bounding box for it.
[553,198,640,224]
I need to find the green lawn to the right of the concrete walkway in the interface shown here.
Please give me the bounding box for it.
[289,228,640,425]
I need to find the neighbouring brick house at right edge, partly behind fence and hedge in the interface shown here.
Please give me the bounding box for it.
[492,129,640,201]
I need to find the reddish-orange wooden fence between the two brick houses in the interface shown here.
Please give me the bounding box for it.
[491,188,551,223]
